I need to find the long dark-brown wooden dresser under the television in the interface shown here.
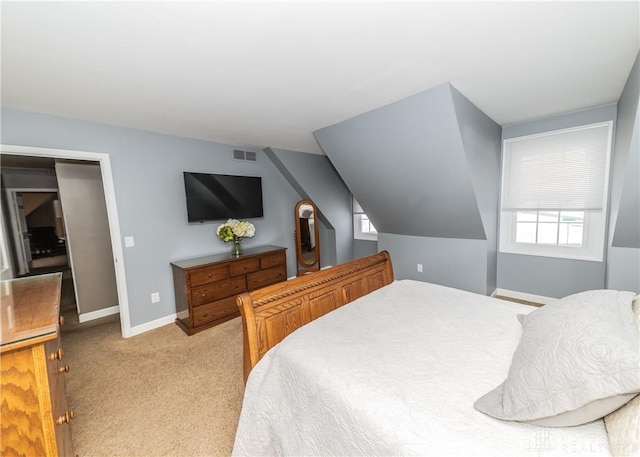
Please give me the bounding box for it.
[171,246,287,335]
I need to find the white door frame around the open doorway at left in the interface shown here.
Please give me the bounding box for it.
[0,144,133,338]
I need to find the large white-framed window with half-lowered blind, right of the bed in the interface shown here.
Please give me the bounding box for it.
[500,122,613,261]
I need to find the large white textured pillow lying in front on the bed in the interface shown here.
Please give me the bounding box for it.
[474,290,640,426]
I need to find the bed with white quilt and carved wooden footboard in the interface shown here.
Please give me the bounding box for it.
[233,252,640,456]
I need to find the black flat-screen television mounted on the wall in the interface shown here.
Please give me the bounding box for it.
[184,171,263,222]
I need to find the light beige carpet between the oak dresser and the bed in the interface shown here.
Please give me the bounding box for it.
[62,281,243,457]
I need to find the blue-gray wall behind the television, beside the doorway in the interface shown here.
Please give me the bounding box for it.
[1,109,300,327]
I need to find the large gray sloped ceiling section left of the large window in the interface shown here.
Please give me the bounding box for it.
[314,84,500,240]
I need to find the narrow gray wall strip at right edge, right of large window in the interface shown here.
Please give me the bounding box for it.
[607,50,640,292]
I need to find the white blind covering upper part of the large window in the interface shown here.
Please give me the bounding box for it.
[502,122,612,211]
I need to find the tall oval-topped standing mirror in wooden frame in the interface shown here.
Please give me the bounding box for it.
[295,200,320,276]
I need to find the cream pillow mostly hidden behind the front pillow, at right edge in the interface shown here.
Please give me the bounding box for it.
[604,295,640,457]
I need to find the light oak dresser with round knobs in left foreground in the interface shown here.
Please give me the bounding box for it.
[0,273,73,457]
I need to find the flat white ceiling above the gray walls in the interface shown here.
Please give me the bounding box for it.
[1,0,640,153]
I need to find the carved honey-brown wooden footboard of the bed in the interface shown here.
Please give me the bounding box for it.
[237,251,393,381]
